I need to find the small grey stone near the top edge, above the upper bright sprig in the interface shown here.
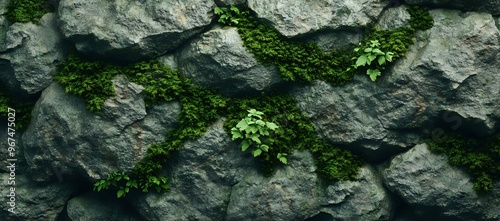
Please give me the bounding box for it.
[377,5,411,30]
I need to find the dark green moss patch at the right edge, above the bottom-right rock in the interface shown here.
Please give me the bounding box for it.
[428,133,500,191]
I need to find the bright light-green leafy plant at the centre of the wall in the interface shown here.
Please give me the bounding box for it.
[231,109,287,164]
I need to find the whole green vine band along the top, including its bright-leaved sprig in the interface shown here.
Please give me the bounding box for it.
[216,6,433,84]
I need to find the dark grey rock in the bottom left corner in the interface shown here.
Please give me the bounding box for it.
[0,173,76,221]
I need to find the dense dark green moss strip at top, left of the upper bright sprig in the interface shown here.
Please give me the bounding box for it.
[217,7,353,84]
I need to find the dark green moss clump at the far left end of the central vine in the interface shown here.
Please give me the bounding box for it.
[55,53,117,113]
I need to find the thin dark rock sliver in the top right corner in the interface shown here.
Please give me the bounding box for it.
[405,0,500,15]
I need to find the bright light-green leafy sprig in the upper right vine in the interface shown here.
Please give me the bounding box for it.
[348,40,394,81]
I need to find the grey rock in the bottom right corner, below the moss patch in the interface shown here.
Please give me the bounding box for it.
[383,144,500,220]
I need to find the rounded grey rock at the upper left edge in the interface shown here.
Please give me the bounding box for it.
[0,13,67,96]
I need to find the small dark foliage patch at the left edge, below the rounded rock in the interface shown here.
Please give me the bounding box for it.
[0,89,35,129]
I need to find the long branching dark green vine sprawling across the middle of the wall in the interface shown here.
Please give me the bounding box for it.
[56,54,362,198]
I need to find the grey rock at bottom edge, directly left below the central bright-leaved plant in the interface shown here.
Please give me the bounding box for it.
[130,121,253,221]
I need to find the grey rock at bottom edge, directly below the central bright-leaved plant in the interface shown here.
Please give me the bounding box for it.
[226,151,320,221]
